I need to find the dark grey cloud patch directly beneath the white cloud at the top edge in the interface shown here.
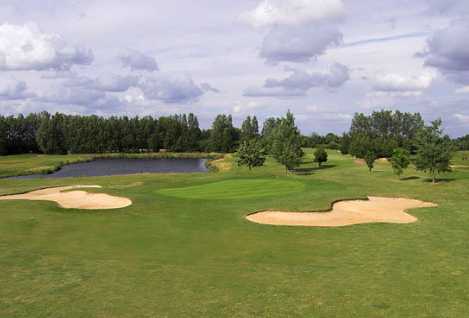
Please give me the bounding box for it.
[260,25,342,64]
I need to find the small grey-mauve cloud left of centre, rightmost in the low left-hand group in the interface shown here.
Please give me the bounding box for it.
[139,75,205,104]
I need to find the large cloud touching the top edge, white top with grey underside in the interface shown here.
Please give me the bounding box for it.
[242,0,345,64]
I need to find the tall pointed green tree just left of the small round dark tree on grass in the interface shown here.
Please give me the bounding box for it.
[272,111,303,174]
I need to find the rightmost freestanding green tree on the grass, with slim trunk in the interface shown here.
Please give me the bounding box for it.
[415,120,453,183]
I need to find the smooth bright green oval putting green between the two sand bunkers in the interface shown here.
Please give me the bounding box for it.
[158,179,305,199]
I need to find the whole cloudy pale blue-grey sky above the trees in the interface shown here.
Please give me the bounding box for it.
[0,0,469,137]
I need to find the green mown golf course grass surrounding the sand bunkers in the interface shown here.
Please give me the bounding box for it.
[0,150,469,318]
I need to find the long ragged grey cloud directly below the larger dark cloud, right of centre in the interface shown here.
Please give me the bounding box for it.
[244,63,350,97]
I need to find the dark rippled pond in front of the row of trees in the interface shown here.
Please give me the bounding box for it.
[13,159,208,179]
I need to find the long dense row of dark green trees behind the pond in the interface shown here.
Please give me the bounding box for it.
[0,112,240,155]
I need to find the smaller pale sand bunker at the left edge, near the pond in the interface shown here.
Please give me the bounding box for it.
[0,185,132,210]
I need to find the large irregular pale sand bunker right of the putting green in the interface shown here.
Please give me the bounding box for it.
[246,197,437,227]
